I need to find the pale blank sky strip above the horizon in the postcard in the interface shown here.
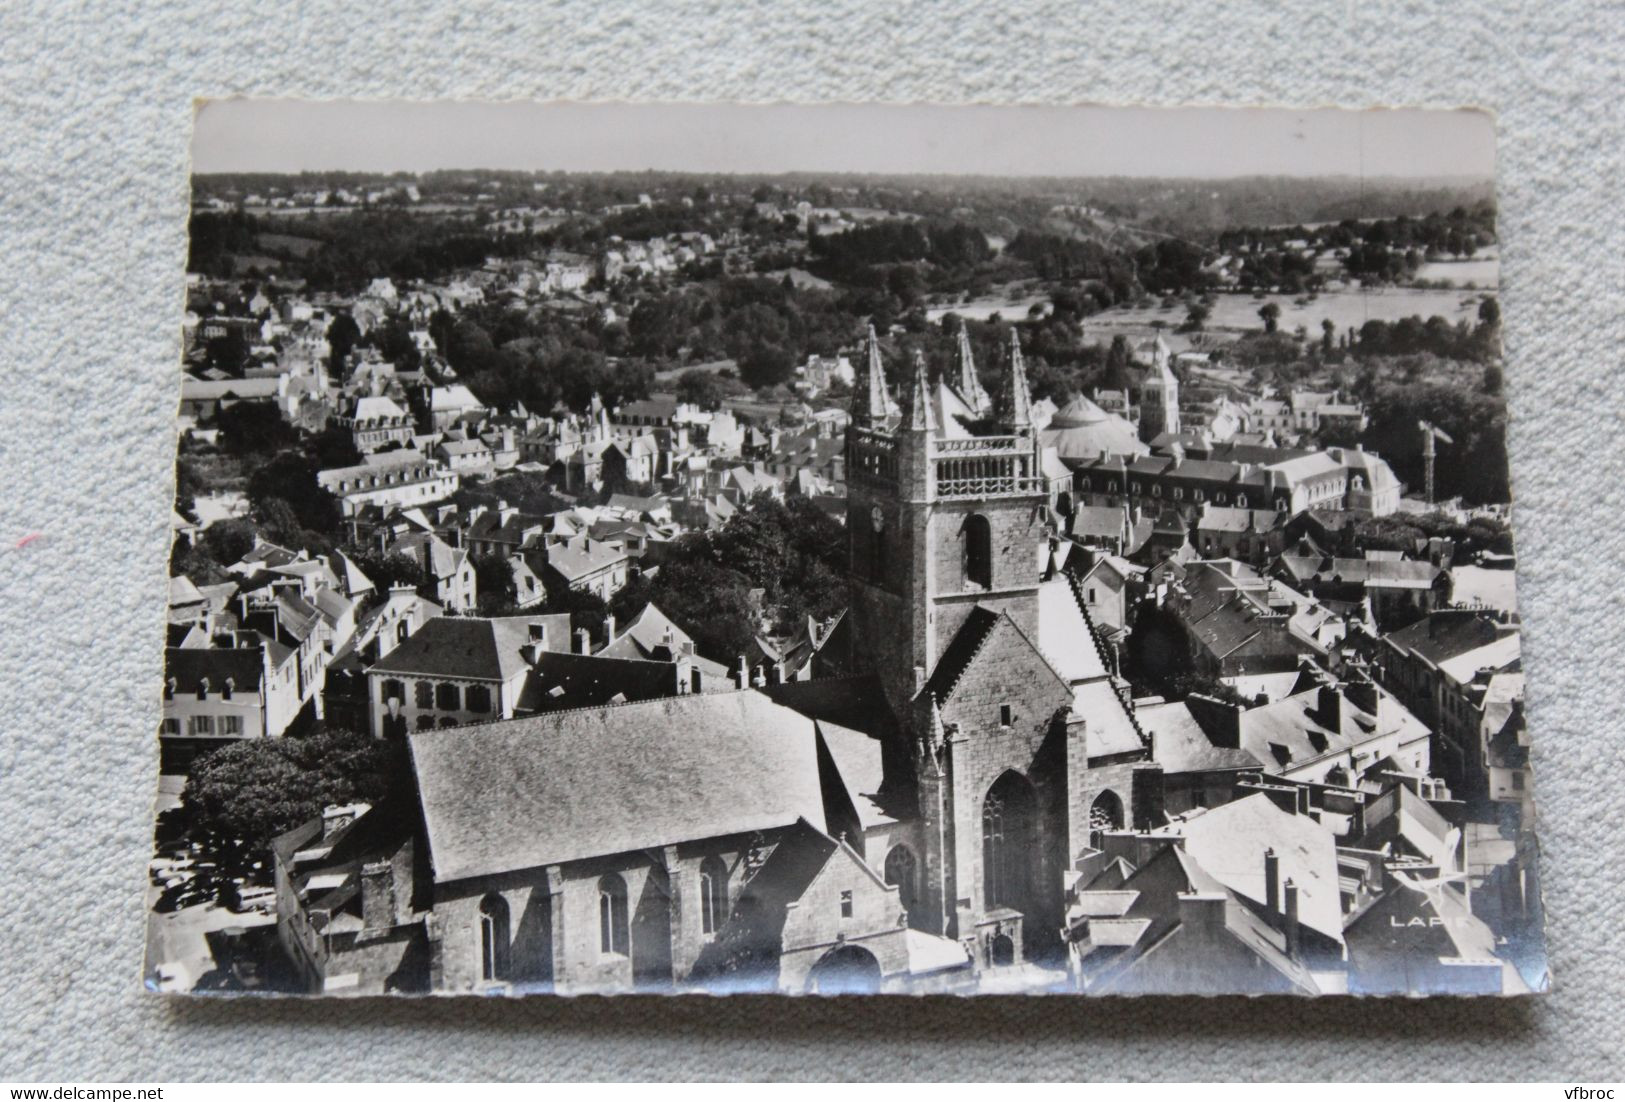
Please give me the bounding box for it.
[192,99,1495,179]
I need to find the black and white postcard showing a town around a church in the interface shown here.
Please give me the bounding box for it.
[145,99,1549,996]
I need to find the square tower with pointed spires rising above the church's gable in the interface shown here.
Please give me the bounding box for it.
[847,328,1047,717]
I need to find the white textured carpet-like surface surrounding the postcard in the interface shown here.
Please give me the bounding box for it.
[0,0,1625,1082]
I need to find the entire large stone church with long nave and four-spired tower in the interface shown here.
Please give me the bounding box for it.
[275,333,1160,993]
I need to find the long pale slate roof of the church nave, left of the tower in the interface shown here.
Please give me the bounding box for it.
[408,691,826,883]
